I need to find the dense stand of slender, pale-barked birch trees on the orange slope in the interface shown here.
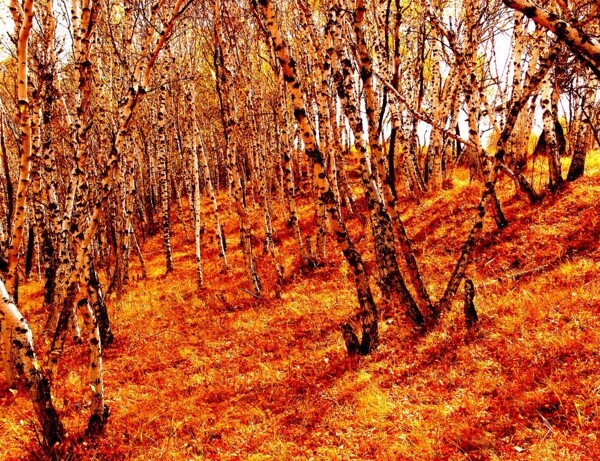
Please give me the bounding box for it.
[0,0,600,447]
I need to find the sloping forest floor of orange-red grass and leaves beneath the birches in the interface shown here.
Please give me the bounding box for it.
[0,154,600,460]
